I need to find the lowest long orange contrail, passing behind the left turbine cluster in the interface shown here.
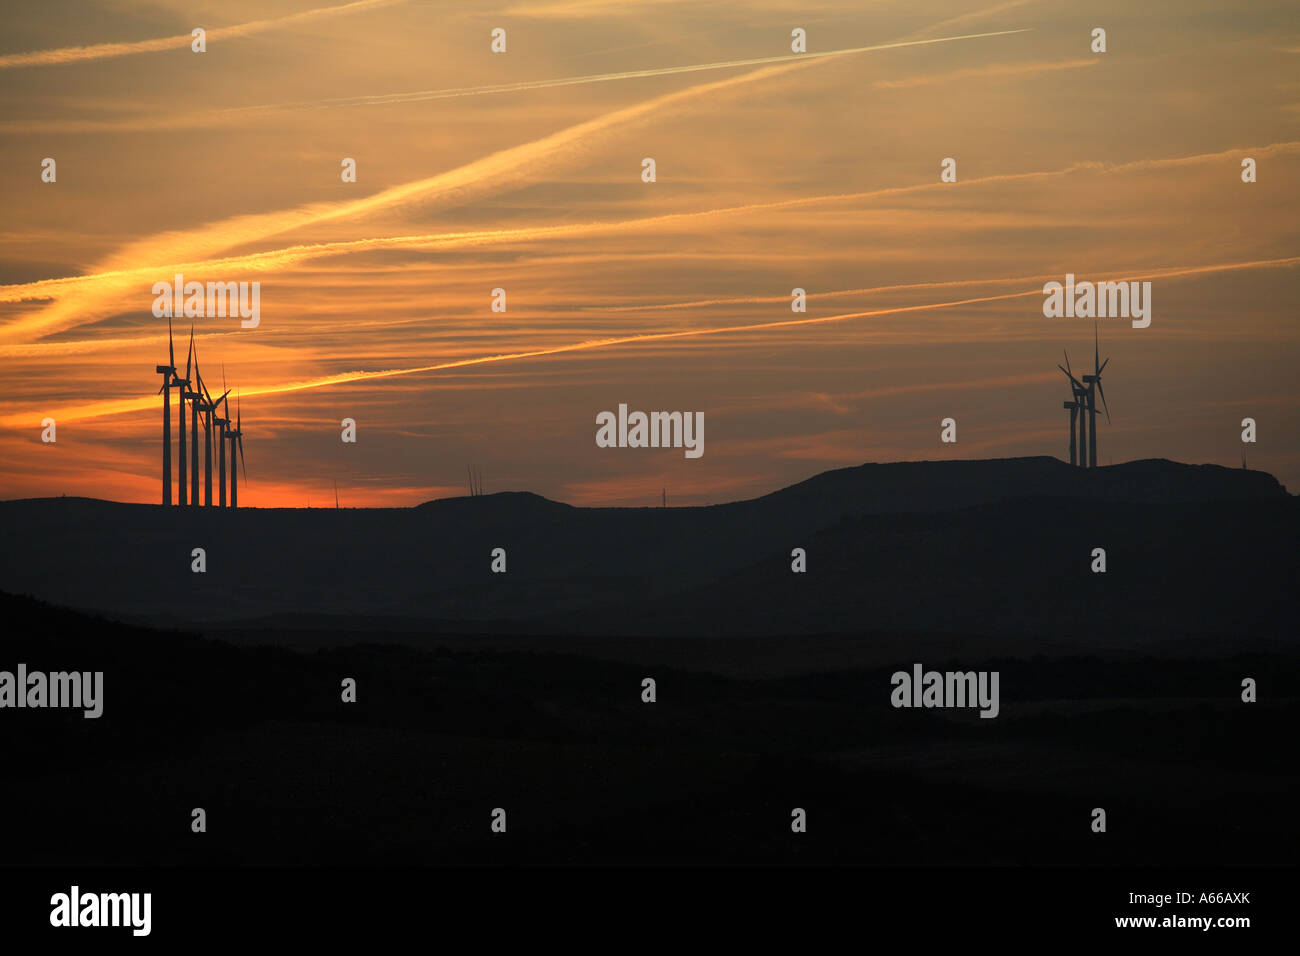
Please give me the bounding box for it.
[0,256,1300,428]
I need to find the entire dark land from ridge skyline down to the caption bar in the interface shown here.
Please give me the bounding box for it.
[0,458,1300,878]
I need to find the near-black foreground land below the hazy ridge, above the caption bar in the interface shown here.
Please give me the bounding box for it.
[0,596,1300,866]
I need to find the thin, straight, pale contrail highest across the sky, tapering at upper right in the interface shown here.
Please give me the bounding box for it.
[220,27,1030,113]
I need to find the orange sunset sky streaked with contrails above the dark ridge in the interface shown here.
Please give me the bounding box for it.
[0,0,1300,506]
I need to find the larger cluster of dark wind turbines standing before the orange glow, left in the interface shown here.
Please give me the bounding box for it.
[155,319,248,507]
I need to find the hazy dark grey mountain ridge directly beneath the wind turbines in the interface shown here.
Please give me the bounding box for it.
[0,458,1300,644]
